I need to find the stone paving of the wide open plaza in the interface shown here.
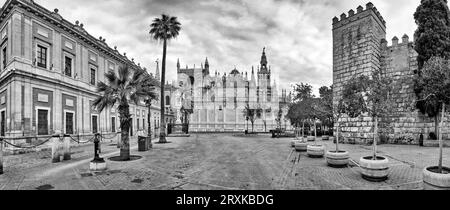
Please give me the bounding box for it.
[0,134,450,190]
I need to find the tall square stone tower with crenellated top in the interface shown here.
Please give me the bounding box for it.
[333,3,386,140]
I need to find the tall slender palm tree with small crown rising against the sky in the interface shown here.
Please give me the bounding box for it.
[150,14,181,143]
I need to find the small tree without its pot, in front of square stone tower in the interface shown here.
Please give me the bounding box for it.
[339,70,393,160]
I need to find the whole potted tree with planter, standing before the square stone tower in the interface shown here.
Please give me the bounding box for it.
[342,69,392,181]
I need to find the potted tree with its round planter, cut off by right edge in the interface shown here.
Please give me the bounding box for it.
[416,57,450,190]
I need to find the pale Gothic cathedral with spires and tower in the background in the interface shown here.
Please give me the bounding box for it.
[177,49,290,132]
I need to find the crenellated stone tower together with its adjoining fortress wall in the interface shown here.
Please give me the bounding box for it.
[333,3,450,144]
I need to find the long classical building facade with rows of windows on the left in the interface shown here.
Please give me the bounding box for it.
[0,0,170,137]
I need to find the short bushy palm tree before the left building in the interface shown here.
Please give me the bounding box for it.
[93,66,154,161]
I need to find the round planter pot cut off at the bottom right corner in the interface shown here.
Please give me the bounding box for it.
[423,166,450,190]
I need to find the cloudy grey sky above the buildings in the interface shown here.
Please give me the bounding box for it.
[0,0,420,93]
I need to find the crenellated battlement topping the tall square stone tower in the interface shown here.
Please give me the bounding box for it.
[333,2,386,30]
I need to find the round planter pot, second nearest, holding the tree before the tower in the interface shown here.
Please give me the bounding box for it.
[359,156,389,182]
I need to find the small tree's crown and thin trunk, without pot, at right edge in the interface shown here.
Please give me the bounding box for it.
[416,57,450,173]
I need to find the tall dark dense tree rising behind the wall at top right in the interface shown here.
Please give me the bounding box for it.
[414,0,450,69]
